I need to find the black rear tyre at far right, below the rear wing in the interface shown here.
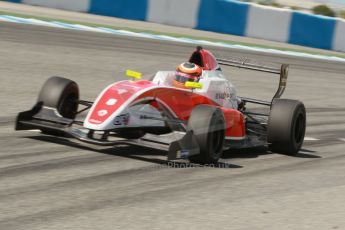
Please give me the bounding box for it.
[267,99,306,155]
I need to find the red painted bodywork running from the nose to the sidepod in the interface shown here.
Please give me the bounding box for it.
[88,80,245,138]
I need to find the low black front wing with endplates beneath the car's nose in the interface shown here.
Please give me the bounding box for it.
[15,102,200,160]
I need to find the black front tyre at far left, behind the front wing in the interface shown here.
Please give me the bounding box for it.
[37,77,79,136]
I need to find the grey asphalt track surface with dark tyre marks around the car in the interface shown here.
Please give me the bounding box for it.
[0,23,345,230]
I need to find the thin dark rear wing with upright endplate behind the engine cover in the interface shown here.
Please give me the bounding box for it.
[217,58,289,106]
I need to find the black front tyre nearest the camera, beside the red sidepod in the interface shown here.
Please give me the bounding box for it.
[187,105,225,164]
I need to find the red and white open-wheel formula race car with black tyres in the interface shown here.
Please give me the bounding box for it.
[15,47,306,164]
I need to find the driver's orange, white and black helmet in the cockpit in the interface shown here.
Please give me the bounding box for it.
[173,62,202,89]
